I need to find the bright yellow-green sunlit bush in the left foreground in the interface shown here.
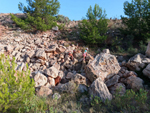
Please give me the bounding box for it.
[0,55,35,112]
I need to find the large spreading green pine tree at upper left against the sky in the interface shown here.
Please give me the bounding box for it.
[11,0,60,31]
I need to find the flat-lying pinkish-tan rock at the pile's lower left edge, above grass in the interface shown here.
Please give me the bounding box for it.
[36,86,53,97]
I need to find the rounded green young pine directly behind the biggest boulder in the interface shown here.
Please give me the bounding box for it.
[79,4,107,44]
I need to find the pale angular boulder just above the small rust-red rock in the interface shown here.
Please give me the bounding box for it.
[44,67,58,78]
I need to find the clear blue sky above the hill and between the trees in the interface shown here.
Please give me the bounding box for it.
[0,0,131,20]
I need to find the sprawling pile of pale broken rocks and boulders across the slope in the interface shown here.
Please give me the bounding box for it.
[0,24,150,101]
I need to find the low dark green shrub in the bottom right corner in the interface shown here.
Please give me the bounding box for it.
[112,89,147,112]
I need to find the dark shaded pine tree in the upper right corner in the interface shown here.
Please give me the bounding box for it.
[121,0,150,40]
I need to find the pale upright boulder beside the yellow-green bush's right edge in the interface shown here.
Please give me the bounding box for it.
[34,72,47,87]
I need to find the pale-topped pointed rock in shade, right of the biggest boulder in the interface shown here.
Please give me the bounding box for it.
[126,53,146,71]
